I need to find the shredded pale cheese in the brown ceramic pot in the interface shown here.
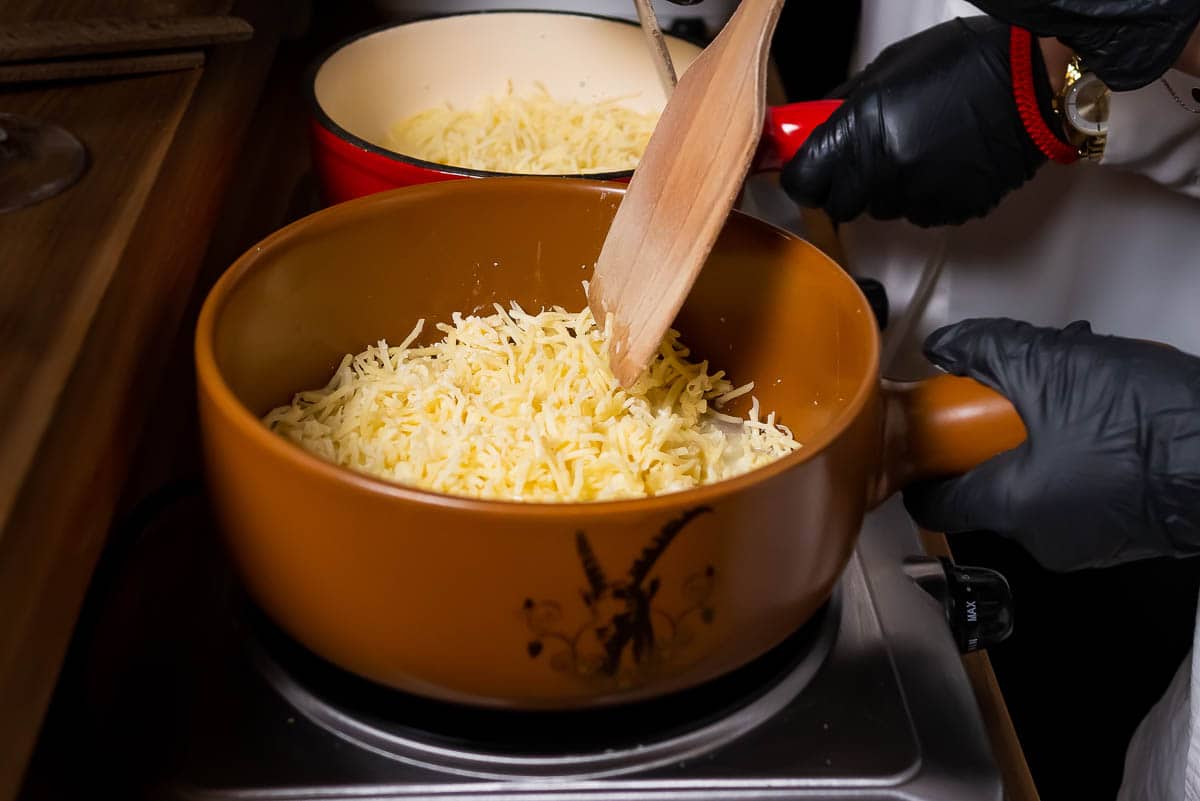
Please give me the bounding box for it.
[264,303,800,502]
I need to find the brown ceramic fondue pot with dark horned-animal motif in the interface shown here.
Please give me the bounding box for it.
[196,177,1025,709]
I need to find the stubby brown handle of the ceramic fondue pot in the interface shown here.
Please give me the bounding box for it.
[876,375,1027,502]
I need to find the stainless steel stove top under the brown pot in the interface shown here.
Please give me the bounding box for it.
[35,500,1002,801]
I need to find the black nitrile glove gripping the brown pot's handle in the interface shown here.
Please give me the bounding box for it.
[905,319,1200,571]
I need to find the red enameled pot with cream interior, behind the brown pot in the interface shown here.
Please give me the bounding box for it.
[308,11,838,204]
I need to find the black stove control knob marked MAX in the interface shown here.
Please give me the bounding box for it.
[905,556,1013,654]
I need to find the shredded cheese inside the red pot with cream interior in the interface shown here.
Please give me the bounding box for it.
[388,83,658,175]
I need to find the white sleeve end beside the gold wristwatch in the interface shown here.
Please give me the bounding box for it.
[1100,70,1200,198]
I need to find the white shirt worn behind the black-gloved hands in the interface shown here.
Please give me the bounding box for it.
[842,0,1200,801]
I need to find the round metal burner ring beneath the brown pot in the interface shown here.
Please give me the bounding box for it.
[244,585,842,779]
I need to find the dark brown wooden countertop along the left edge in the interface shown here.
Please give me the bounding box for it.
[0,0,284,799]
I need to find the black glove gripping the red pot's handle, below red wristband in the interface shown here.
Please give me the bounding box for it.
[782,17,1052,225]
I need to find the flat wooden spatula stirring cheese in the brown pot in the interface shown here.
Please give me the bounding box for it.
[588,0,784,386]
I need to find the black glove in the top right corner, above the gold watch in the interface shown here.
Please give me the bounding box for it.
[971,0,1200,91]
